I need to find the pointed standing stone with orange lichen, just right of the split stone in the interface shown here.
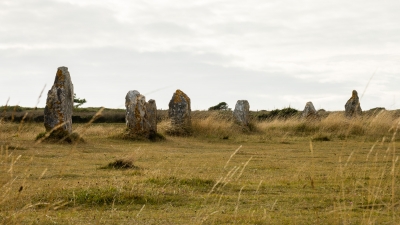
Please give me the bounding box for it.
[168,89,192,135]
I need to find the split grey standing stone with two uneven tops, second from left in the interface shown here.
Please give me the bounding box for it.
[125,90,157,138]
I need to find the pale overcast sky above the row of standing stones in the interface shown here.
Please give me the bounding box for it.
[0,0,400,110]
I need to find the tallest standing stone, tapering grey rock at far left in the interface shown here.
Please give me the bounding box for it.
[44,67,74,134]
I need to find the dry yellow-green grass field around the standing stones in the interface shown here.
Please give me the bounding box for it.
[0,111,400,224]
